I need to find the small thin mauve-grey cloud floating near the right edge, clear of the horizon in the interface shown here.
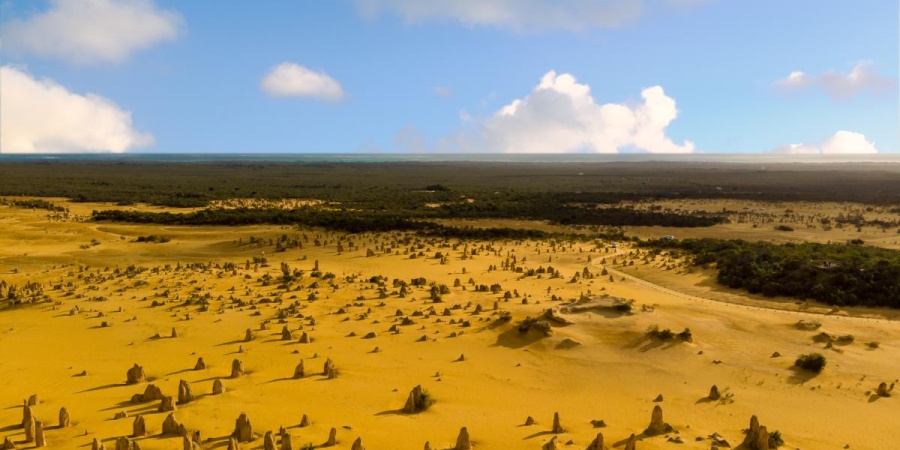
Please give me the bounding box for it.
[775,61,896,98]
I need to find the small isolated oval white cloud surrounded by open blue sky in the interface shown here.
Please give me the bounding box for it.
[259,62,344,101]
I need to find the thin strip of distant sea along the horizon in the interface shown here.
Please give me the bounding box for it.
[0,153,900,164]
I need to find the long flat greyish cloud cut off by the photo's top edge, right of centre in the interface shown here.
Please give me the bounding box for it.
[356,0,644,31]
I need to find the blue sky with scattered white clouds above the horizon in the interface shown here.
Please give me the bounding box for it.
[0,0,900,153]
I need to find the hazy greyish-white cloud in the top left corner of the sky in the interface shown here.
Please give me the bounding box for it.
[3,0,184,64]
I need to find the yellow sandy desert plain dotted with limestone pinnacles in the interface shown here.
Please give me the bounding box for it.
[0,198,900,450]
